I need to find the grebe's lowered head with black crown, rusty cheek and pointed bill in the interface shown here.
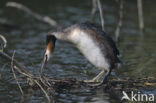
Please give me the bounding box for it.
[42,35,56,69]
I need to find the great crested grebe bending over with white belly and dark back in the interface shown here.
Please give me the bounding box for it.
[42,22,120,84]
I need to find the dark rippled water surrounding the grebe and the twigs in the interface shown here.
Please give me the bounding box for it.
[0,0,156,103]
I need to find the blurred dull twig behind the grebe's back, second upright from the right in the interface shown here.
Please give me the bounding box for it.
[115,0,123,41]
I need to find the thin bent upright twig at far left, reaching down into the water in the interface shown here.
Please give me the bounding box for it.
[11,51,24,95]
